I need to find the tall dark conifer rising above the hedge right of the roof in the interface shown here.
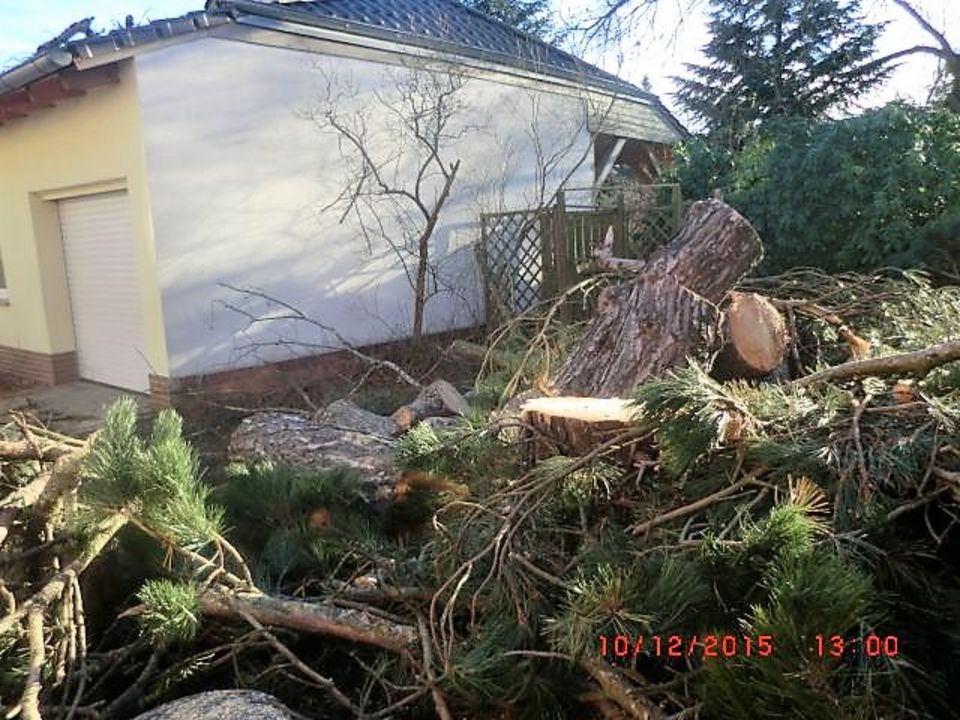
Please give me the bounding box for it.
[676,0,889,148]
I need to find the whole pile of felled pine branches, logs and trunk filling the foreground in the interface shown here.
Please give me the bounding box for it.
[0,203,960,720]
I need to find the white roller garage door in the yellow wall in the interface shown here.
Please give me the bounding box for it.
[59,192,149,391]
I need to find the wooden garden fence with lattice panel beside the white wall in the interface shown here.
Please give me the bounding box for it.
[479,185,684,323]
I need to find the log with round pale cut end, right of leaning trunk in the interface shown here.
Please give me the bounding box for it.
[713,292,790,380]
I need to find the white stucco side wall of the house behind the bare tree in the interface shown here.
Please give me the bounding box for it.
[136,38,593,377]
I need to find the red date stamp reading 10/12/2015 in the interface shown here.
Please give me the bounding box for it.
[599,635,774,658]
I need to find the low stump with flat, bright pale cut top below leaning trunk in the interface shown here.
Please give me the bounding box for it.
[520,397,637,465]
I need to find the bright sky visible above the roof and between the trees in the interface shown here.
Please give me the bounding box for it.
[0,0,960,125]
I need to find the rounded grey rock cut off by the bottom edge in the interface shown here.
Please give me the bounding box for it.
[134,690,296,720]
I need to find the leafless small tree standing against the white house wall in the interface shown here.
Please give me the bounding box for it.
[310,63,475,343]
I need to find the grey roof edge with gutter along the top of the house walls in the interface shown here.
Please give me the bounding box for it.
[0,0,688,143]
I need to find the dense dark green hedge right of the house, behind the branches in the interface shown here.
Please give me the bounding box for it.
[672,103,960,273]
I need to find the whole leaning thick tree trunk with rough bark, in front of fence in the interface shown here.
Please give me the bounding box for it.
[553,200,763,397]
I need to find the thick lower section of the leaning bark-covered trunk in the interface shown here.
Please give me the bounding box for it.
[553,276,721,398]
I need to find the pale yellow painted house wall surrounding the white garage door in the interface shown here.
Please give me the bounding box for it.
[0,60,168,375]
